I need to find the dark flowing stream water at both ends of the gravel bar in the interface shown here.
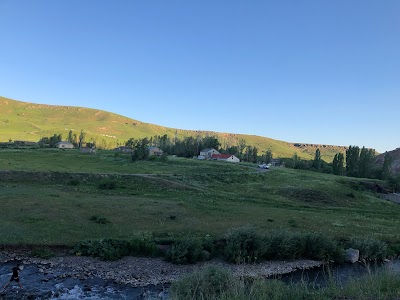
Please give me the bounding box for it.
[0,260,400,300]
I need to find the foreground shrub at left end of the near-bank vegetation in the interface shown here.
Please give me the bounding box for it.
[170,266,231,300]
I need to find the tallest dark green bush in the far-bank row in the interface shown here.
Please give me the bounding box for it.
[223,226,261,263]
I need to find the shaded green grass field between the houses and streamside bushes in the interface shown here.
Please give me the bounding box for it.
[0,149,400,245]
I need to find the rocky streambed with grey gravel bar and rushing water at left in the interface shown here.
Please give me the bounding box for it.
[0,252,322,300]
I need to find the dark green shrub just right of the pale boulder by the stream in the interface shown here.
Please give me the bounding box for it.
[349,237,388,261]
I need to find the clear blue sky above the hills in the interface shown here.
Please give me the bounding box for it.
[0,0,400,152]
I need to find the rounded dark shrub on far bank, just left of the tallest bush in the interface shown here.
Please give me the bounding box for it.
[166,236,203,264]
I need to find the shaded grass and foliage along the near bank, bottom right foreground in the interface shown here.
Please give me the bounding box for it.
[170,268,400,300]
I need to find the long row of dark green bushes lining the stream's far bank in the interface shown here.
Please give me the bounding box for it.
[74,226,388,264]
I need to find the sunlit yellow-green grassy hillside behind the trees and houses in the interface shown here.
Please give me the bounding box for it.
[0,97,345,162]
